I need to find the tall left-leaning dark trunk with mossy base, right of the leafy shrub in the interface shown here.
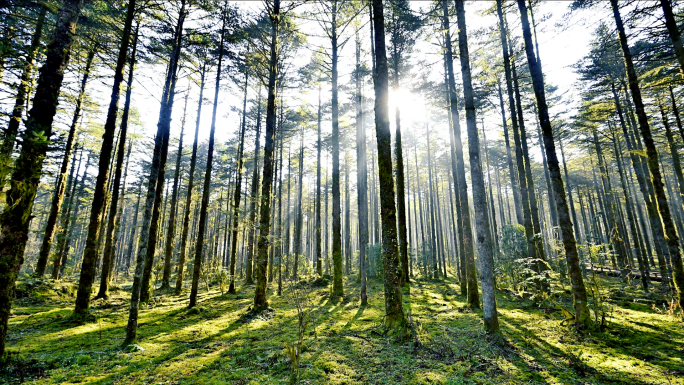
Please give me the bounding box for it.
[518,0,590,325]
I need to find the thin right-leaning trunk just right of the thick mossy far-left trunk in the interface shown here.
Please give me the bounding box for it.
[34,46,96,277]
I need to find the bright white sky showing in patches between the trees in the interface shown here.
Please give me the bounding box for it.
[0,1,606,186]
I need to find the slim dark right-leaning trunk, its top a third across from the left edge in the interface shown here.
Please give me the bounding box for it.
[188,12,228,308]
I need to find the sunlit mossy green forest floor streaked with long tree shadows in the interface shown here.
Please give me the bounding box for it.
[0,277,684,385]
